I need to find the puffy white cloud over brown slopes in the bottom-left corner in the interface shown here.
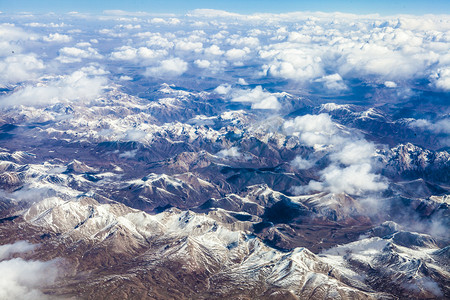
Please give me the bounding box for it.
[0,241,58,300]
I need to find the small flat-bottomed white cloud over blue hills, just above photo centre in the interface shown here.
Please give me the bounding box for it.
[231,86,281,109]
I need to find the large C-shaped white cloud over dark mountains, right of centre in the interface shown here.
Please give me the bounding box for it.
[283,114,387,195]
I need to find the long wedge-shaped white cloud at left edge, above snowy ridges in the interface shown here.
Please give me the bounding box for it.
[0,67,107,107]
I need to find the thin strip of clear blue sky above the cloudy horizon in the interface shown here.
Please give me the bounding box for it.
[0,0,450,15]
